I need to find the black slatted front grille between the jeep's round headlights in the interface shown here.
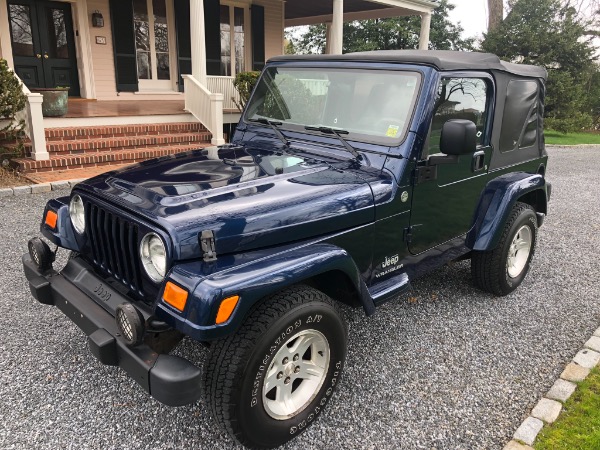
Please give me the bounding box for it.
[85,202,142,293]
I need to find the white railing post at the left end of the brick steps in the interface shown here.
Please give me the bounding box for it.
[10,69,50,160]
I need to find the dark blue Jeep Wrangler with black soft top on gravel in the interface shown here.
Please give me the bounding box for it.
[23,51,550,448]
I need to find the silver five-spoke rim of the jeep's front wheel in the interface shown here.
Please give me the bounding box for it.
[262,330,330,420]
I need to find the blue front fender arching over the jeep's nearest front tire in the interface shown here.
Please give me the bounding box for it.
[156,243,375,340]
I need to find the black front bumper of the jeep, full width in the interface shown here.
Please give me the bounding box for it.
[22,254,201,406]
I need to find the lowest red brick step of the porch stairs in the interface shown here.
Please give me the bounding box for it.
[12,142,210,173]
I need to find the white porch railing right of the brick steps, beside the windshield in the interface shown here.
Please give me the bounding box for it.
[182,75,225,145]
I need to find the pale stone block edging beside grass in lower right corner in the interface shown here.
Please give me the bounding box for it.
[504,328,600,450]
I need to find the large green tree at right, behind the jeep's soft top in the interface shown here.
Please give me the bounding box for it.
[481,0,598,132]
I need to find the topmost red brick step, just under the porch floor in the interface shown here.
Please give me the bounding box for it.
[45,122,208,141]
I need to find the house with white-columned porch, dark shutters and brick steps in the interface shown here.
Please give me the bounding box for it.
[0,0,437,176]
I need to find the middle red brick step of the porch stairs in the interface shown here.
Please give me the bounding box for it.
[26,132,211,155]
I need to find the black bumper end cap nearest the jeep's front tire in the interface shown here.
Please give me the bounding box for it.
[150,355,202,406]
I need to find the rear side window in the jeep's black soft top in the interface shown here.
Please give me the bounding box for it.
[500,80,539,152]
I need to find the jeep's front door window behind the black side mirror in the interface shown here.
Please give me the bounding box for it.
[423,78,489,158]
